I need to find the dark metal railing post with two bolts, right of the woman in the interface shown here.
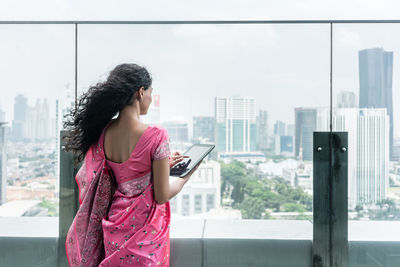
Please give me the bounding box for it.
[313,132,348,267]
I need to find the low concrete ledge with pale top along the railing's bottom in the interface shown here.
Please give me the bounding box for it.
[0,220,400,267]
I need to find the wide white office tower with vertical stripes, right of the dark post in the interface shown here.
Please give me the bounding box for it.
[318,108,389,208]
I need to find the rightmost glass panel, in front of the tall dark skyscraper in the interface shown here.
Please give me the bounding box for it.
[333,24,400,266]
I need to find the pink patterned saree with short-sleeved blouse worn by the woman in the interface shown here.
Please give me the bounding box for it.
[65,126,170,267]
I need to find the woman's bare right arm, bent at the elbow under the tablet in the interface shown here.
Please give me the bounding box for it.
[153,158,200,204]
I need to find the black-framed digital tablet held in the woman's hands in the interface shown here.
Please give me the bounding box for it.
[170,144,215,178]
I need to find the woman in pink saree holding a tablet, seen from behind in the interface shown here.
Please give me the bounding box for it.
[65,64,195,266]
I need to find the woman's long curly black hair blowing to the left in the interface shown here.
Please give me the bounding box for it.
[64,64,152,162]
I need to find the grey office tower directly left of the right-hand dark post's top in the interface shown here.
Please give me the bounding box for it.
[295,108,317,161]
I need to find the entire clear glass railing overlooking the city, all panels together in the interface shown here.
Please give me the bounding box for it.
[0,21,400,266]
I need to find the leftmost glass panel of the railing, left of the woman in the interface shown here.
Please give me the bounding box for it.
[0,25,74,222]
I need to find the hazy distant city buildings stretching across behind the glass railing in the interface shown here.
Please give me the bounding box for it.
[0,48,400,219]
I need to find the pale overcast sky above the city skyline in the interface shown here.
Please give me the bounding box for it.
[0,0,400,136]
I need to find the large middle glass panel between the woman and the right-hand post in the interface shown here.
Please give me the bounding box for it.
[79,25,329,226]
